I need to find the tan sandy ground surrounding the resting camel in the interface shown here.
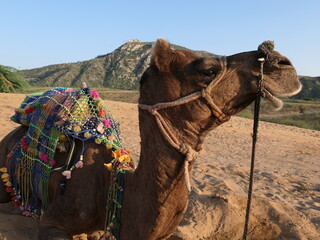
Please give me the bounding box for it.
[0,93,320,240]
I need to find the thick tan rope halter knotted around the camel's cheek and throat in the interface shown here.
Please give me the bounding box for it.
[138,57,227,192]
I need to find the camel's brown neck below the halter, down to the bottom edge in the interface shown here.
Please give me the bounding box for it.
[122,112,195,240]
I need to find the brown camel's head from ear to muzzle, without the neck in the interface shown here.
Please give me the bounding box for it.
[139,39,301,149]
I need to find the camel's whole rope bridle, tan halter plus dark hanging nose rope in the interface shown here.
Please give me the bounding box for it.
[138,53,265,240]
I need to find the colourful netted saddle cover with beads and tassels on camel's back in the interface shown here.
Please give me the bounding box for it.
[0,88,134,226]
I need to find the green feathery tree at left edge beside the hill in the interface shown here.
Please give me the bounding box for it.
[0,65,29,93]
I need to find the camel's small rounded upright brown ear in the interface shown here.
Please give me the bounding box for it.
[152,38,172,72]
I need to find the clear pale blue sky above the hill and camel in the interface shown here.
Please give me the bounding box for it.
[0,0,320,76]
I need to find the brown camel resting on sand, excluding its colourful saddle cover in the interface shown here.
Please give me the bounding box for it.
[0,38,301,240]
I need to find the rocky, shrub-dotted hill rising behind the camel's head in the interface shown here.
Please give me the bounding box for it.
[20,40,216,89]
